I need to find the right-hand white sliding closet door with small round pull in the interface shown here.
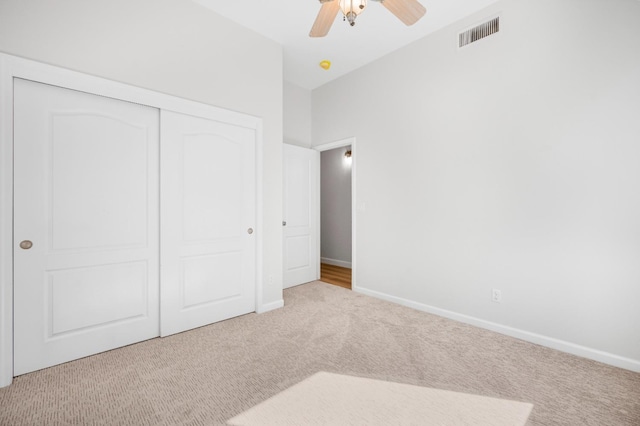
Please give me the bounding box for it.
[160,111,256,336]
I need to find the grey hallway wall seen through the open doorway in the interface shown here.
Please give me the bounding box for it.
[320,147,351,267]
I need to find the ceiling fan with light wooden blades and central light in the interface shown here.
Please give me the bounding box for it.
[309,0,427,37]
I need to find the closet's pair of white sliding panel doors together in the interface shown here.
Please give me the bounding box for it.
[13,78,258,376]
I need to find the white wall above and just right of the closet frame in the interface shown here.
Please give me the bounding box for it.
[0,0,283,304]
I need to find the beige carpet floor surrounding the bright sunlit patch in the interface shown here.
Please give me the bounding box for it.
[0,282,640,426]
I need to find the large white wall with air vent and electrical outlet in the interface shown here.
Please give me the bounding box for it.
[312,0,640,371]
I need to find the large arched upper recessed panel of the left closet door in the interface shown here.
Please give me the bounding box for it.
[47,111,149,250]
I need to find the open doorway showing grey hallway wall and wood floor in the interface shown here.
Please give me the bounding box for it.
[316,139,355,289]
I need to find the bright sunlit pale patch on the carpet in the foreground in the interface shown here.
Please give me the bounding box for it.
[228,372,533,426]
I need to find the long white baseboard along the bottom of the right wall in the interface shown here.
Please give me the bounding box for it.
[353,287,640,373]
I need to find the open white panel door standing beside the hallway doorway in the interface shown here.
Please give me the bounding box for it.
[282,144,320,288]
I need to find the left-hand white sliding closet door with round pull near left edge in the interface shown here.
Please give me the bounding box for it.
[14,79,159,375]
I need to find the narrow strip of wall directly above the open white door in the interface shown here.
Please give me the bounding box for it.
[284,81,311,148]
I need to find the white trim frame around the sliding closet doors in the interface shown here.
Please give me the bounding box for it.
[0,53,264,387]
